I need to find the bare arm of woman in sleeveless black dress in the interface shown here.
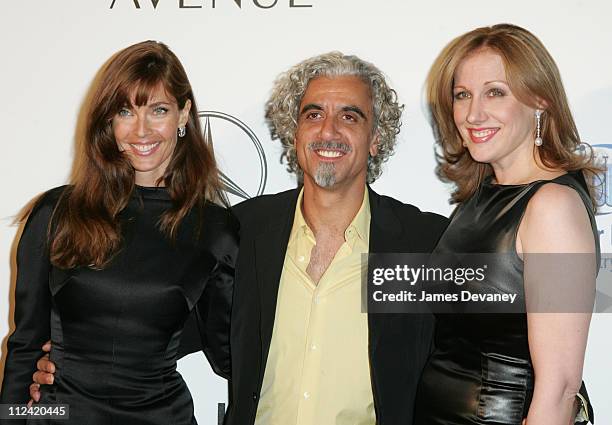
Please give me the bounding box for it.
[517,184,597,425]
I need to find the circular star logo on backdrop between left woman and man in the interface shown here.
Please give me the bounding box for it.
[198,111,268,199]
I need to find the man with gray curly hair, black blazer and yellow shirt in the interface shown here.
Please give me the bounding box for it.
[220,52,446,425]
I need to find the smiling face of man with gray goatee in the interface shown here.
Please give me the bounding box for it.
[295,76,377,189]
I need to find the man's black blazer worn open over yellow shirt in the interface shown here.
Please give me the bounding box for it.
[225,188,447,425]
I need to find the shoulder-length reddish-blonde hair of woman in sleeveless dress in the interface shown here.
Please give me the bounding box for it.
[426,24,598,202]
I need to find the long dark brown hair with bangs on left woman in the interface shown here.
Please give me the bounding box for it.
[49,41,225,269]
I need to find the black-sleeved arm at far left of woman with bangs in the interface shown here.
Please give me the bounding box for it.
[0,195,54,404]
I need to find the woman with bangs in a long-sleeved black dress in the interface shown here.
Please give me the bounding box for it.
[0,41,238,425]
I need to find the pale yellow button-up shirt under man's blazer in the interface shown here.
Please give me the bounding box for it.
[255,189,376,425]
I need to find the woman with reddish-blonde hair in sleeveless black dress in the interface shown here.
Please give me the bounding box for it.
[415,24,599,425]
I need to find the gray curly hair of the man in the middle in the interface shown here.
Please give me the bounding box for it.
[266,52,404,183]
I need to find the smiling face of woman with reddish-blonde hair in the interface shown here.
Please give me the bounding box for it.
[453,49,535,173]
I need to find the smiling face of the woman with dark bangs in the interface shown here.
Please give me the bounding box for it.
[112,85,191,186]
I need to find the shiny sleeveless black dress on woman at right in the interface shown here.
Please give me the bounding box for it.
[414,173,599,425]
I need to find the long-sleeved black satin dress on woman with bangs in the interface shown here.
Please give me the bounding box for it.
[0,187,238,425]
